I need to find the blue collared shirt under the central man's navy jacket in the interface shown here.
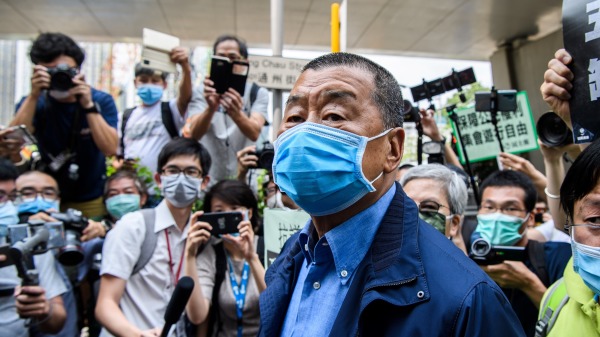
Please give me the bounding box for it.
[281,185,396,337]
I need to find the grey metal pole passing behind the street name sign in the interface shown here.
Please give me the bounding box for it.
[271,0,284,141]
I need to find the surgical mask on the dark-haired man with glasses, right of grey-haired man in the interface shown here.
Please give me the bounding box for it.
[475,212,529,246]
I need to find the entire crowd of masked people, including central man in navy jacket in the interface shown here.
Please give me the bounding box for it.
[0,33,600,337]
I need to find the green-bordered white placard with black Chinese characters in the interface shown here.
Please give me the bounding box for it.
[452,91,539,164]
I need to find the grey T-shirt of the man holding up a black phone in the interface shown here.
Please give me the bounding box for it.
[188,82,269,184]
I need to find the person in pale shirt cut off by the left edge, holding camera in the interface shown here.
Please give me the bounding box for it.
[0,159,67,337]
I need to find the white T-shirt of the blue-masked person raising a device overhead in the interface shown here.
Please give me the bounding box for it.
[118,99,186,173]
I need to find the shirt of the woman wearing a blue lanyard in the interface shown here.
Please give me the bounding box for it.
[198,237,260,337]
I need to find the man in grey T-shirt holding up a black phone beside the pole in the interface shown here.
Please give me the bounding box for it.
[186,35,269,183]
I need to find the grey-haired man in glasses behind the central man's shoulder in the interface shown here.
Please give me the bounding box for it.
[400,164,468,254]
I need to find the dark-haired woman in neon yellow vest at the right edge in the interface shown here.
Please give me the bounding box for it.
[536,139,600,336]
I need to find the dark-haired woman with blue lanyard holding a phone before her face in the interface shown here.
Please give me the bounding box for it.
[198,180,266,336]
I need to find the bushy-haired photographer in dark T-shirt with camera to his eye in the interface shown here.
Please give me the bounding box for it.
[11,33,118,217]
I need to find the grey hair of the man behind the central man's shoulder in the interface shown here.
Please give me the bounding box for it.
[400,164,469,215]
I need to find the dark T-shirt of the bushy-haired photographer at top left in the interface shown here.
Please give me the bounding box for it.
[17,88,118,202]
